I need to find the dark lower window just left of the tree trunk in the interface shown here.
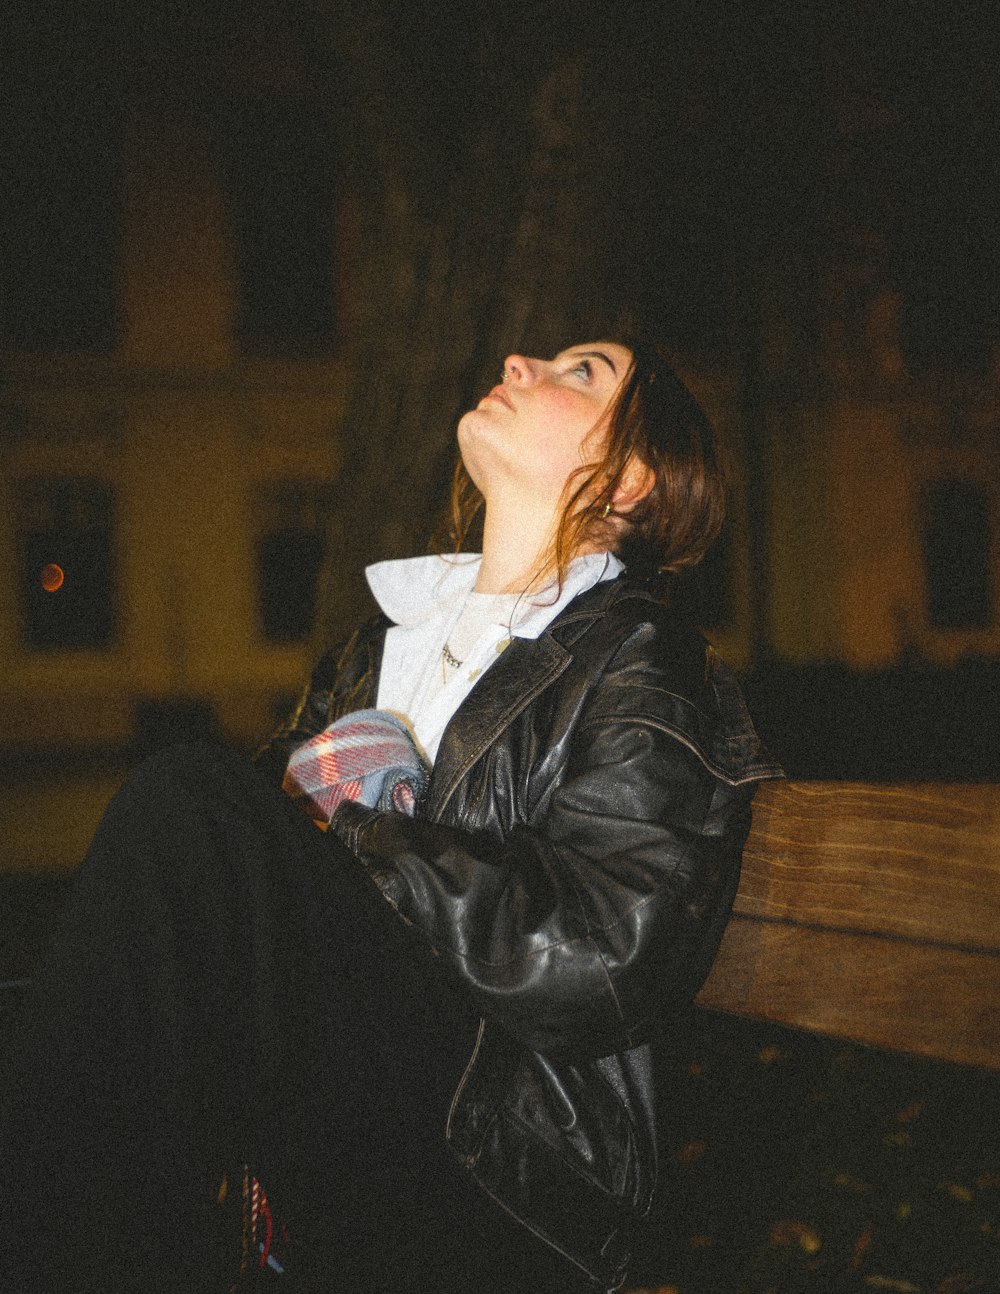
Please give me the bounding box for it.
[256,481,332,643]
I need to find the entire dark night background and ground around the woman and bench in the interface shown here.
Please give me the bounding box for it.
[0,0,1000,1294]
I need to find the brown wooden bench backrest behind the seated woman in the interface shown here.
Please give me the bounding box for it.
[699,782,1000,1069]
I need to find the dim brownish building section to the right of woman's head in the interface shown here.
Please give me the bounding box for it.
[672,80,1000,674]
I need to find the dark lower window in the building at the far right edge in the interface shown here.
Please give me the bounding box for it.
[924,480,994,629]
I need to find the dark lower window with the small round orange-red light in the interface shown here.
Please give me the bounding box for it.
[16,476,118,650]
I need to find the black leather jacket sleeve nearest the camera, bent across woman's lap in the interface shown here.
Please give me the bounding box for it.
[331,652,753,1056]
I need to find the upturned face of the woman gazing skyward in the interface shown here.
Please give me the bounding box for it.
[458,342,631,516]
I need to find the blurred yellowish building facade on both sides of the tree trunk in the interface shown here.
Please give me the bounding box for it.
[0,63,1000,753]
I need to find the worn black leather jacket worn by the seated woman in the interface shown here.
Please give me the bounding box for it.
[256,577,780,1290]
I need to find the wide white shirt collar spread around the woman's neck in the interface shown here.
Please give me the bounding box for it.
[365,553,625,638]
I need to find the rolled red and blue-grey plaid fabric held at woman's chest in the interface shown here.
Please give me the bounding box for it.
[282,710,427,820]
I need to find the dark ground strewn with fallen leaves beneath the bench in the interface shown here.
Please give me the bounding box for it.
[0,872,1000,1294]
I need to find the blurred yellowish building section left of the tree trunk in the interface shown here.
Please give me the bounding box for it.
[0,106,347,754]
